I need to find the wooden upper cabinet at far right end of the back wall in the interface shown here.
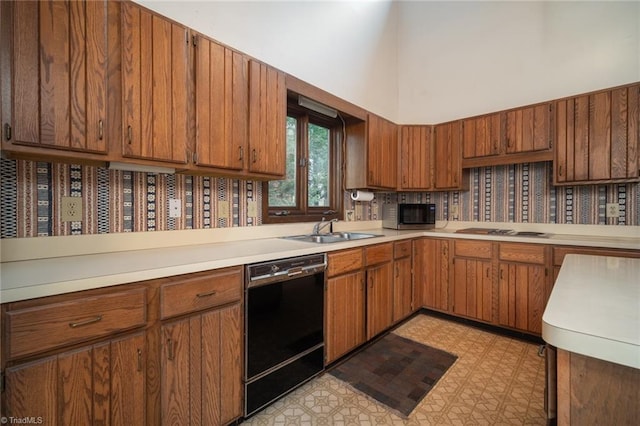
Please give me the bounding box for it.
[554,84,640,185]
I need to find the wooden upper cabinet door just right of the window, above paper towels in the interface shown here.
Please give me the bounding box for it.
[367,114,398,189]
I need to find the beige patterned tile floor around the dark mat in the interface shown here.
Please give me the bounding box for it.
[242,315,545,426]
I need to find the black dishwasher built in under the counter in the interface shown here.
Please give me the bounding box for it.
[244,254,327,416]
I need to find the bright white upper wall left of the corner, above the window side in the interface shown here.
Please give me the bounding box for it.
[137,0,398,118]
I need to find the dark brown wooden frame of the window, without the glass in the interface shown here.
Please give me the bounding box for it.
[262,103,344,223]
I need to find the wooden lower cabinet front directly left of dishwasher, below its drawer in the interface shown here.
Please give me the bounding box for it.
[160,304,243,425]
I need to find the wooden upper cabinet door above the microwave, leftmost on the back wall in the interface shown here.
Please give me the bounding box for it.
[398,126,433,190]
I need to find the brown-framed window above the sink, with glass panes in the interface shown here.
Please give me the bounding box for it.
[263,106,342,223]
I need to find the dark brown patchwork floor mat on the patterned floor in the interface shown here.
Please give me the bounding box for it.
[329,333,458,417]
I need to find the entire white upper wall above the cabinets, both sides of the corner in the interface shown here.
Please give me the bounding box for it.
[138,0,640,123]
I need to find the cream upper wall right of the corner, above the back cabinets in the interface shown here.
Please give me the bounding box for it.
[398,1,640,123]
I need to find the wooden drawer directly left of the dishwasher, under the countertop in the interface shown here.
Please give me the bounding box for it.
[160,267,242,319]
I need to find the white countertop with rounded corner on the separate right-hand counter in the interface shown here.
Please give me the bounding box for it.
[542,254,640,369]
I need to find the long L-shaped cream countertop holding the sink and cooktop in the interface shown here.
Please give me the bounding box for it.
[0,221,640,303]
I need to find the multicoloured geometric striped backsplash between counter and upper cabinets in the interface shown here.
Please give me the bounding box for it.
[0,159,640,238]
